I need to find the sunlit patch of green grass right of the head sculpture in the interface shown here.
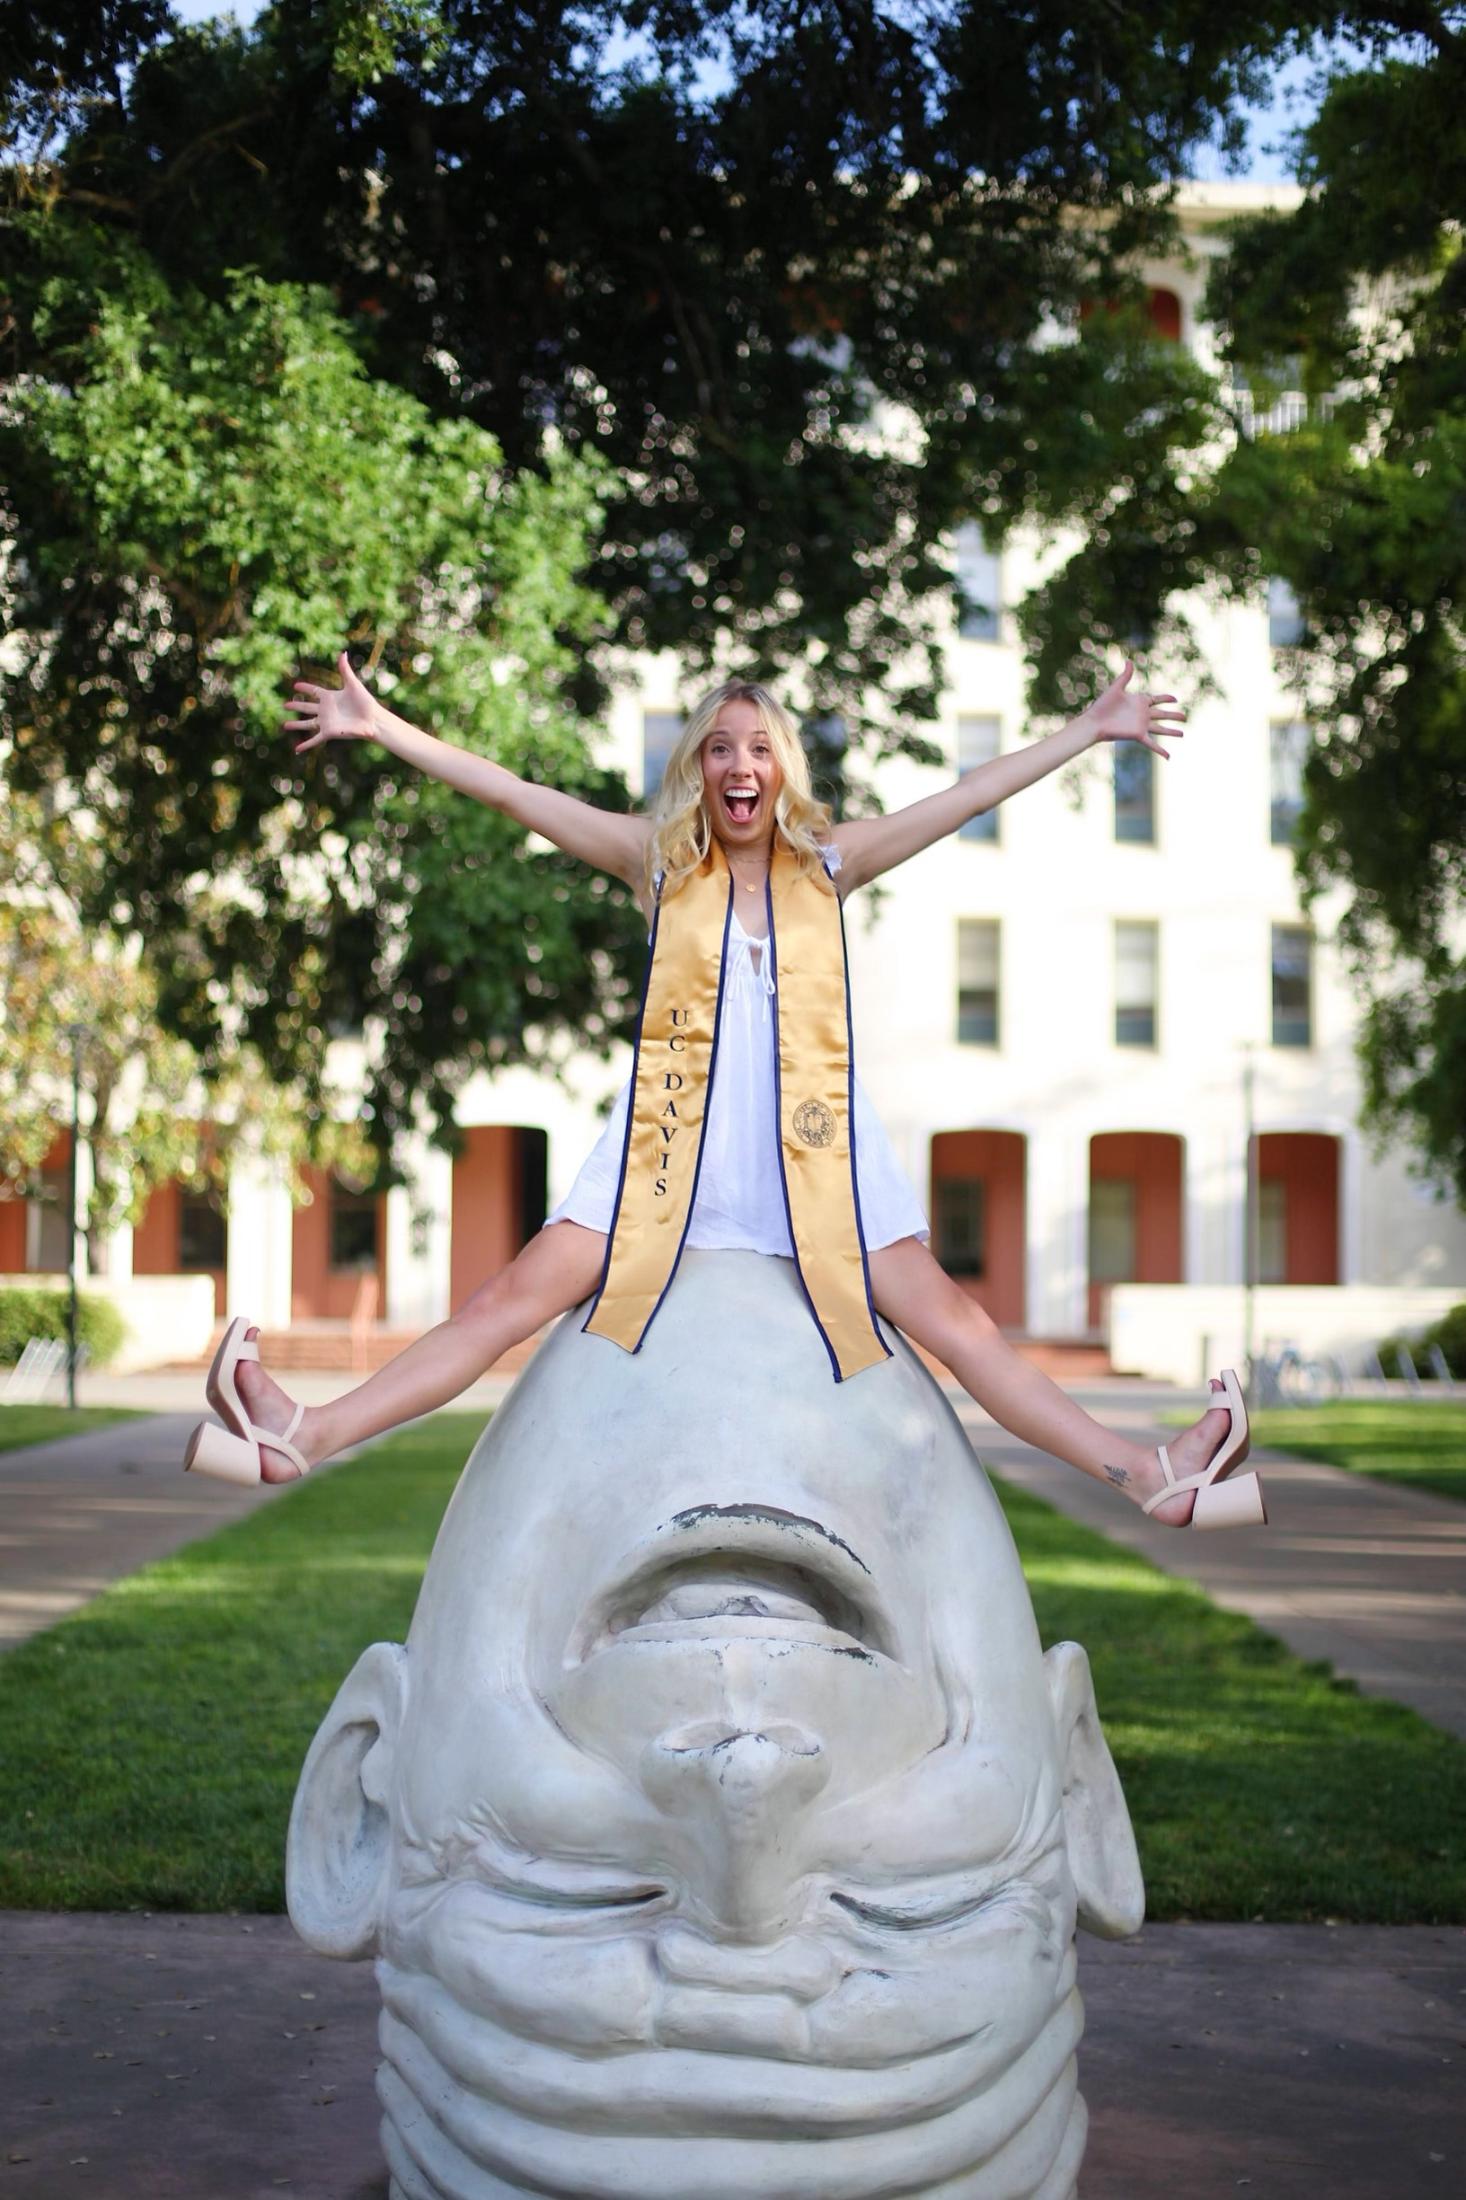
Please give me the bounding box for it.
[981,1483,1466,1921]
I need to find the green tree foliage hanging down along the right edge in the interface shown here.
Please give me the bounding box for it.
[1213,25,1466,1206]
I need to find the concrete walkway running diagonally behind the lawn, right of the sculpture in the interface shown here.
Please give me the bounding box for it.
[953,1379,1466,1740]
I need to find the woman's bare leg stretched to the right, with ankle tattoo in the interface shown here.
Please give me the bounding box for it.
[869,1239,1230,1527]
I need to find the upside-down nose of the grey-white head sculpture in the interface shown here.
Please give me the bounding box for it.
[641,1723,830,1940]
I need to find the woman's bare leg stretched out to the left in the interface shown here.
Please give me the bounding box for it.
[238,1223,605,1483]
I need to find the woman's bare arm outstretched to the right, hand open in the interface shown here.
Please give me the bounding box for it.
[834,662,1186,893]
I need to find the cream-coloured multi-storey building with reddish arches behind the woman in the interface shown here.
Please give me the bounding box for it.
[14,185,1466,1379]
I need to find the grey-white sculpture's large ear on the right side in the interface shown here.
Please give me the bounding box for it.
[1043,1643,1145,1940]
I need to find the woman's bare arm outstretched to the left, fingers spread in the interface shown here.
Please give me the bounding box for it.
[284,651,652,891]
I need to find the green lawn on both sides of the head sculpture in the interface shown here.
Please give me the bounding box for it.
[0,1415,1466,1923]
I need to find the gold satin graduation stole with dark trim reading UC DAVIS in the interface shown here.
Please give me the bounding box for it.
[586,840,889,1382]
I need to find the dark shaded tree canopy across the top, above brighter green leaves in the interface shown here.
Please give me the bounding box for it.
[15,0,1400,750]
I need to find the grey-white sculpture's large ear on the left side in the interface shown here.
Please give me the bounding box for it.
[286,1643,407,1956]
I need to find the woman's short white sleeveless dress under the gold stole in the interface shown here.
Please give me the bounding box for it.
[550,849,929,1261]
